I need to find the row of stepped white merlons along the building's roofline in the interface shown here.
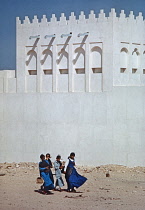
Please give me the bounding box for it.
[16,8,145,26]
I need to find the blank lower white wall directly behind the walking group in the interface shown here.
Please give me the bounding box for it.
[0,87,145,166]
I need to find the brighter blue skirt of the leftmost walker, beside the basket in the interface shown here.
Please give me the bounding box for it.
[41,172,54,191]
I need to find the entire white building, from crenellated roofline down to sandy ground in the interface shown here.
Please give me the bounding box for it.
[0,9,145,166]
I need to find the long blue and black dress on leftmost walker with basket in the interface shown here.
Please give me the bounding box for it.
[39,160,54,191]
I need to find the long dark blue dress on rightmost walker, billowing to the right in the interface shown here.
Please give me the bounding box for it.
[65,159,87,190]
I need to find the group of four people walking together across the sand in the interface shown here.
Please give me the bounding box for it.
[39,152,87,194]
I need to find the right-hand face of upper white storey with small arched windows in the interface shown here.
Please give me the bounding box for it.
[113,10,145,86]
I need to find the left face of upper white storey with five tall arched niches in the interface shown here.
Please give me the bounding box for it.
[17,10,113,92]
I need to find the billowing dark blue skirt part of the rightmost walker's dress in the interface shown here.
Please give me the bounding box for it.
[67,168,87,189]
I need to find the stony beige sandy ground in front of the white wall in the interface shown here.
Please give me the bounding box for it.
[0,163,145,210]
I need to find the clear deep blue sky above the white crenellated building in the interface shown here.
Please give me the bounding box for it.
[0,0,145,70]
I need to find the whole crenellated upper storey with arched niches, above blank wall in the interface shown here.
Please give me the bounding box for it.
[16,8,145,92]
